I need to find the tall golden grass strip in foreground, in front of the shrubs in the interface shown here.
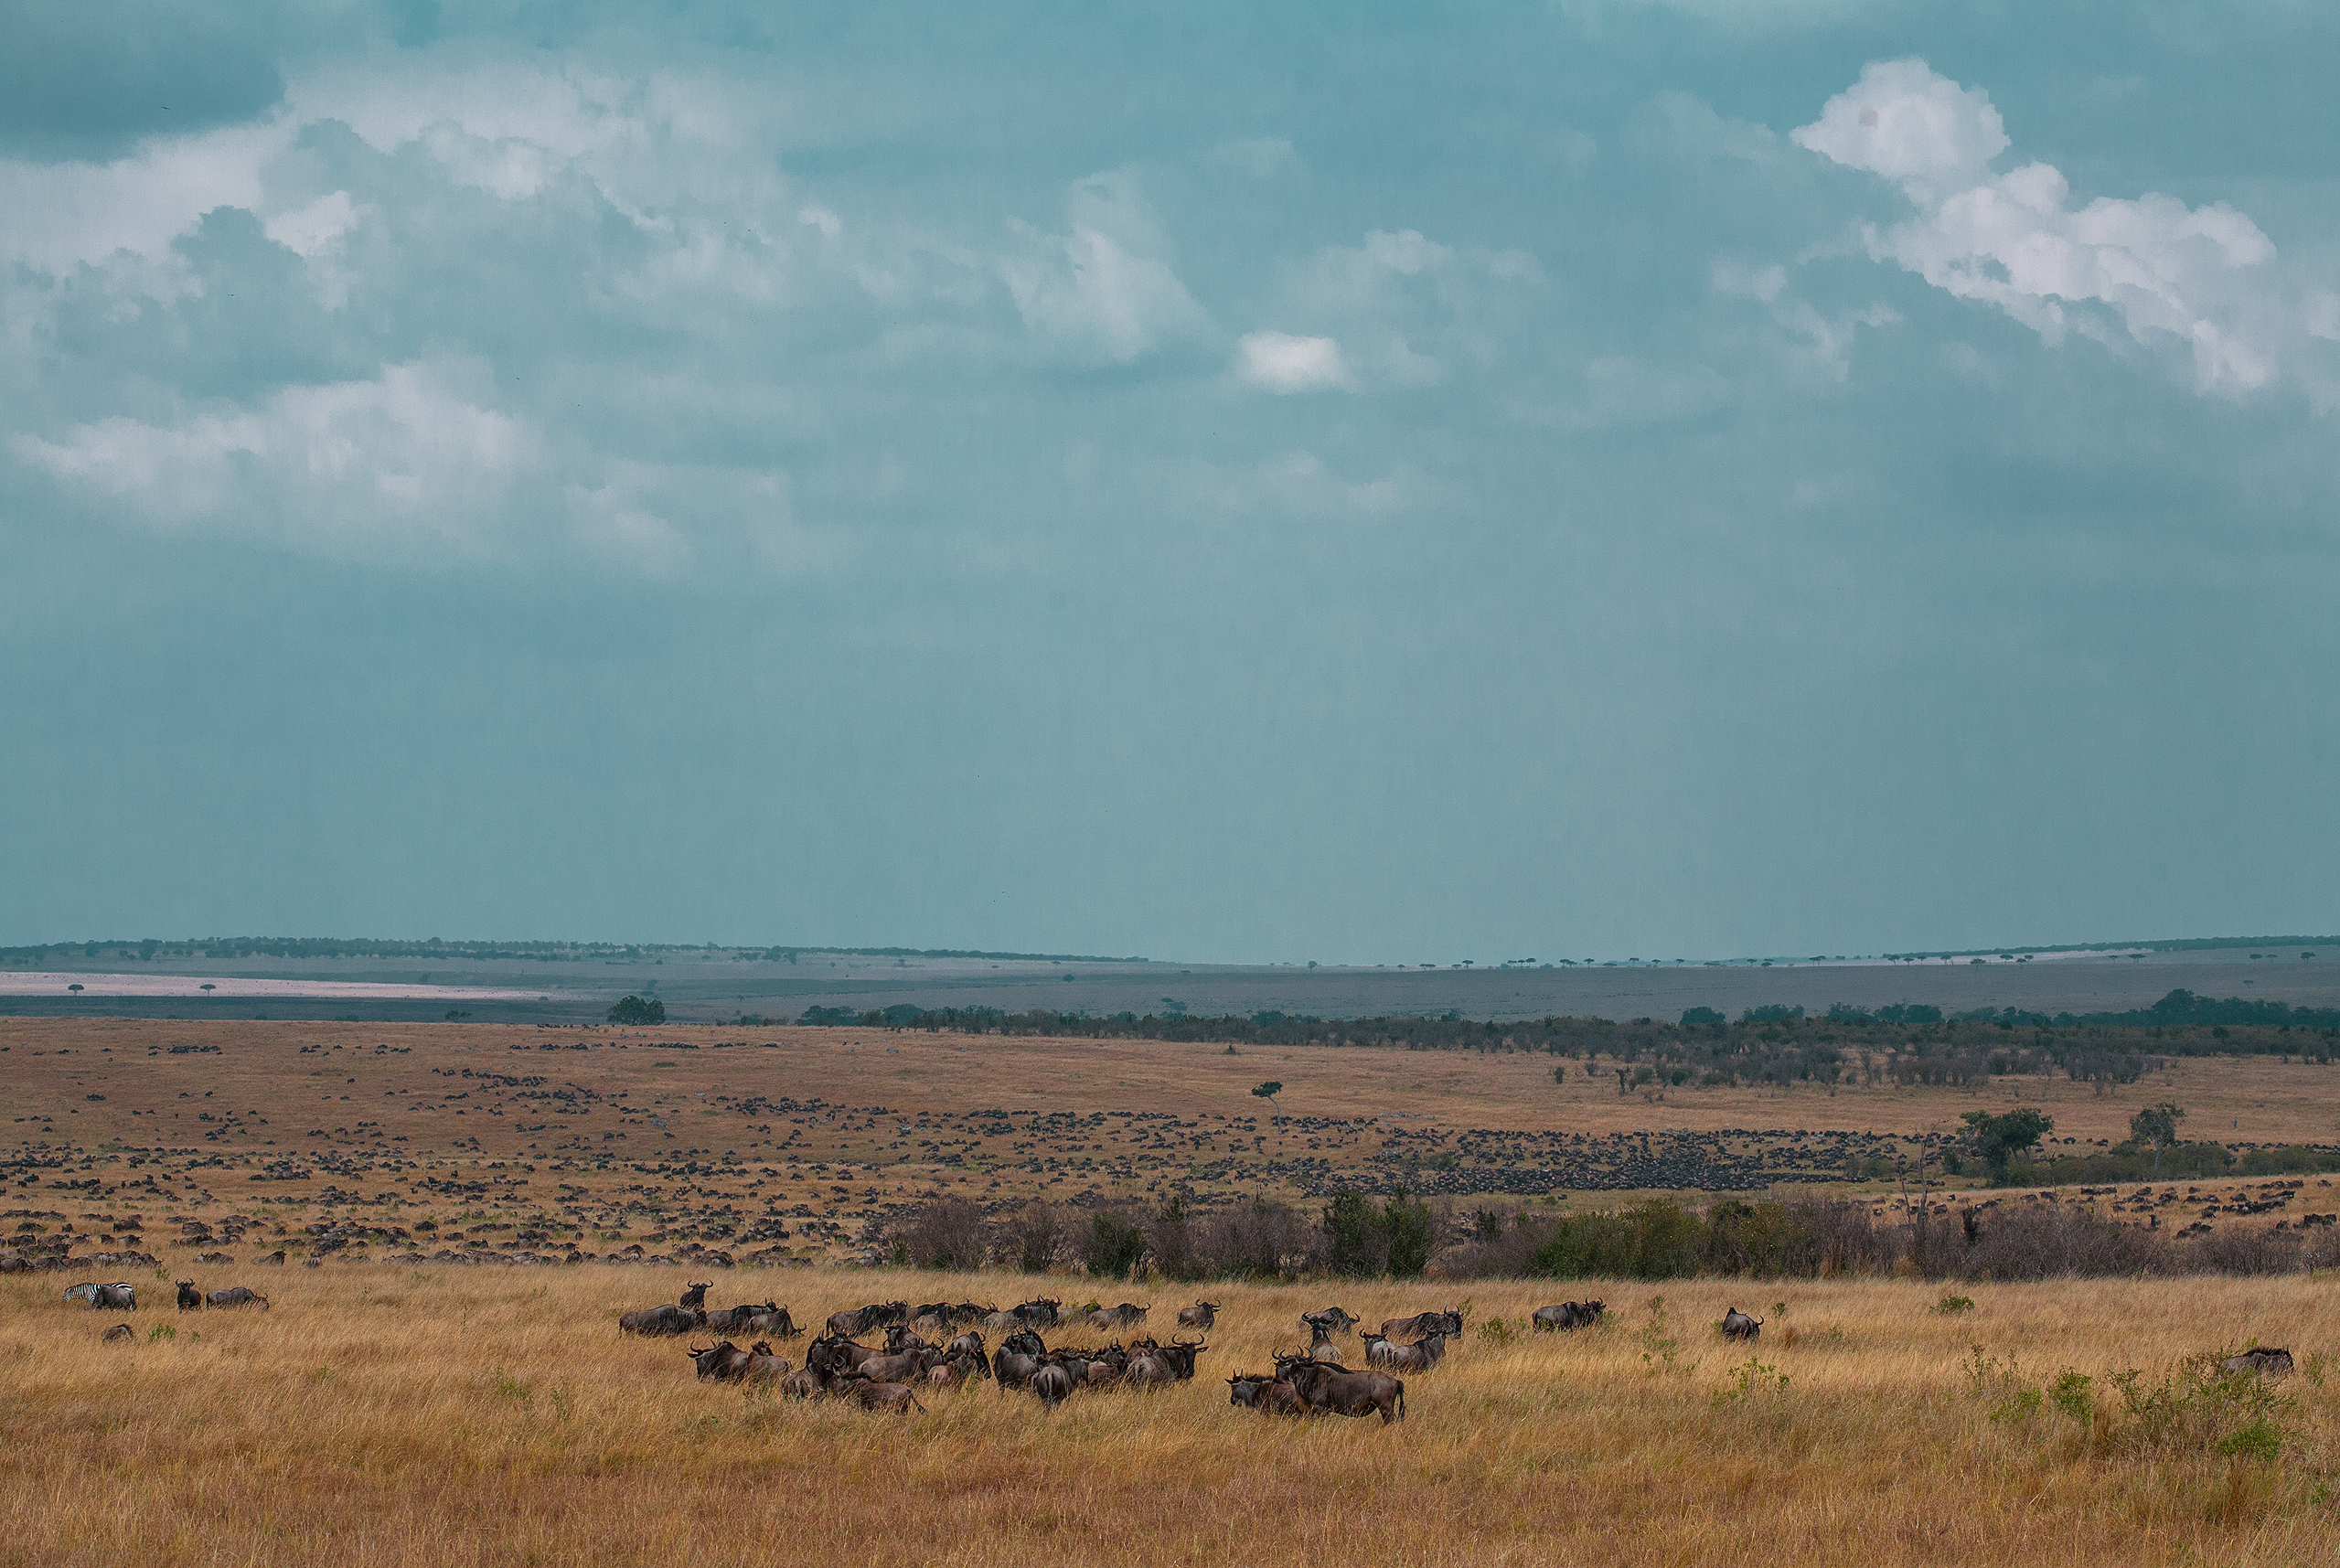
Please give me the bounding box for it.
[0,1264,2340,1568]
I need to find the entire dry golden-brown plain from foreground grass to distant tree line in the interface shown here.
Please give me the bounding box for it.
[0,1020,2340,1565]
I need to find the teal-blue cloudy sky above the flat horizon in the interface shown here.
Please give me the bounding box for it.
[0,0,2340,965]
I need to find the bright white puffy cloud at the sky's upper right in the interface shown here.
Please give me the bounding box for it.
[1792,61,2307,393]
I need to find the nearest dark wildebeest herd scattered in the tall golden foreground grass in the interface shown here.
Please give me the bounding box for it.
[66,1280,2293,1425]
